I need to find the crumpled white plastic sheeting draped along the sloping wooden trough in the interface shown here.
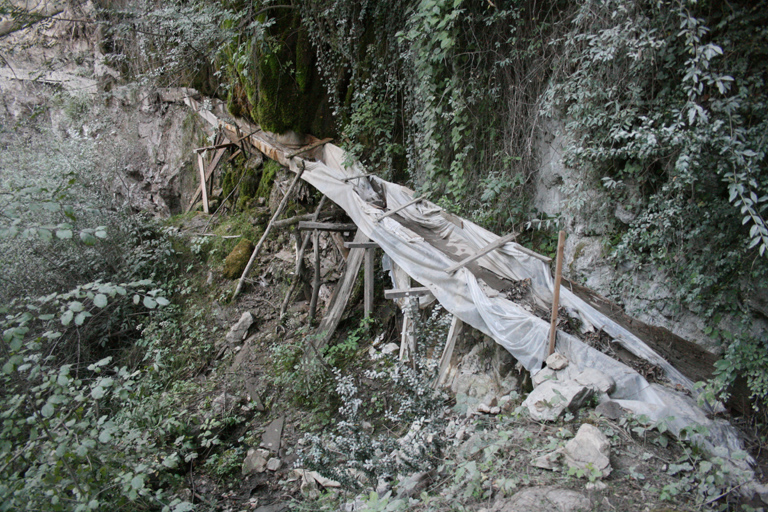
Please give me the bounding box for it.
[185,99,741,464]
